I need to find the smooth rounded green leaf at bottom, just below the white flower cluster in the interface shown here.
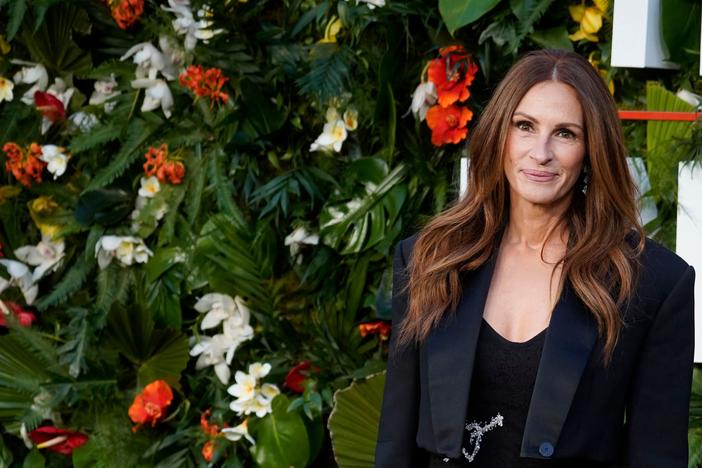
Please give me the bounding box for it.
[251,395,309,468]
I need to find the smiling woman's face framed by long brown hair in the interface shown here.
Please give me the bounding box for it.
[504,81,585,207]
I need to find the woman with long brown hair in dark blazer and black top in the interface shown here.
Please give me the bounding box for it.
[376,51,694,468]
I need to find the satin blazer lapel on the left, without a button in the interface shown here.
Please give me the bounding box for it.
[425,255,496,458]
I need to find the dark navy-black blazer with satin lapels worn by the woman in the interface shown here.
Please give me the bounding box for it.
[375,236,695,468]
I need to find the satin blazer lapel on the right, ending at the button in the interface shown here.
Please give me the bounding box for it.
[521,282,597,458]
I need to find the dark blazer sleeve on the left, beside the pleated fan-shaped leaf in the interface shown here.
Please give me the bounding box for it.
[375,242,427,468]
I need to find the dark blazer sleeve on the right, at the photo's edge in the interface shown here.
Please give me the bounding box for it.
[627,266,695,468]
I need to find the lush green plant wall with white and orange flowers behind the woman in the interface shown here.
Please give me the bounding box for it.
[0,0,700,467]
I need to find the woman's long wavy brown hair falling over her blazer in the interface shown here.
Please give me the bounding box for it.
[398,50,645,362]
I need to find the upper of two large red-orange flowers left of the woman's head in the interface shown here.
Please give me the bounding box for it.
[428,45,478,107]
